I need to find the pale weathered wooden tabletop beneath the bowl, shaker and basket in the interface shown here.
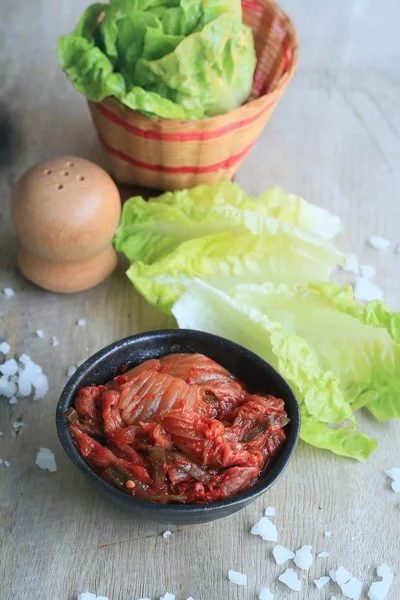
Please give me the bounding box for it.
[0,0,400,600]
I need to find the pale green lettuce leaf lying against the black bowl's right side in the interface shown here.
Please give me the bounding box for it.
[172,280,400,460]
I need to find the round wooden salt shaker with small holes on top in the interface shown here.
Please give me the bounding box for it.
[12,156,121,293]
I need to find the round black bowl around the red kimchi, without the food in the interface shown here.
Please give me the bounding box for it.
[56,329,300,525]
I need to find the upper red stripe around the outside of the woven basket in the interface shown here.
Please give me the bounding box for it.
[95,100,276,142]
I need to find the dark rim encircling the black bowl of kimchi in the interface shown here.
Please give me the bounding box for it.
[56,329,300,516]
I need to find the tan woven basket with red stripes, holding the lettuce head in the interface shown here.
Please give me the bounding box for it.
[89,0,298,190]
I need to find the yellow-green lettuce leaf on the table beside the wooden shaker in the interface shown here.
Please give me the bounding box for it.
[115,183,343,313]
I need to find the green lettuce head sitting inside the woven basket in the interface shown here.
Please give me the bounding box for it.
[58,0,256,119]
